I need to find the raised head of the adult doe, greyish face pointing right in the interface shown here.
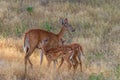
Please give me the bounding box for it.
[59,18,75,32]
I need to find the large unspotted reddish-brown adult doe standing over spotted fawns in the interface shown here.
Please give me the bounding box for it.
[24,18,75,74]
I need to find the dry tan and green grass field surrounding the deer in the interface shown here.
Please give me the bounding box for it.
[0,0,120,80]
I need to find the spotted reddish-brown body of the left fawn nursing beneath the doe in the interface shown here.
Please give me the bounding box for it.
[46,46,72,67]
